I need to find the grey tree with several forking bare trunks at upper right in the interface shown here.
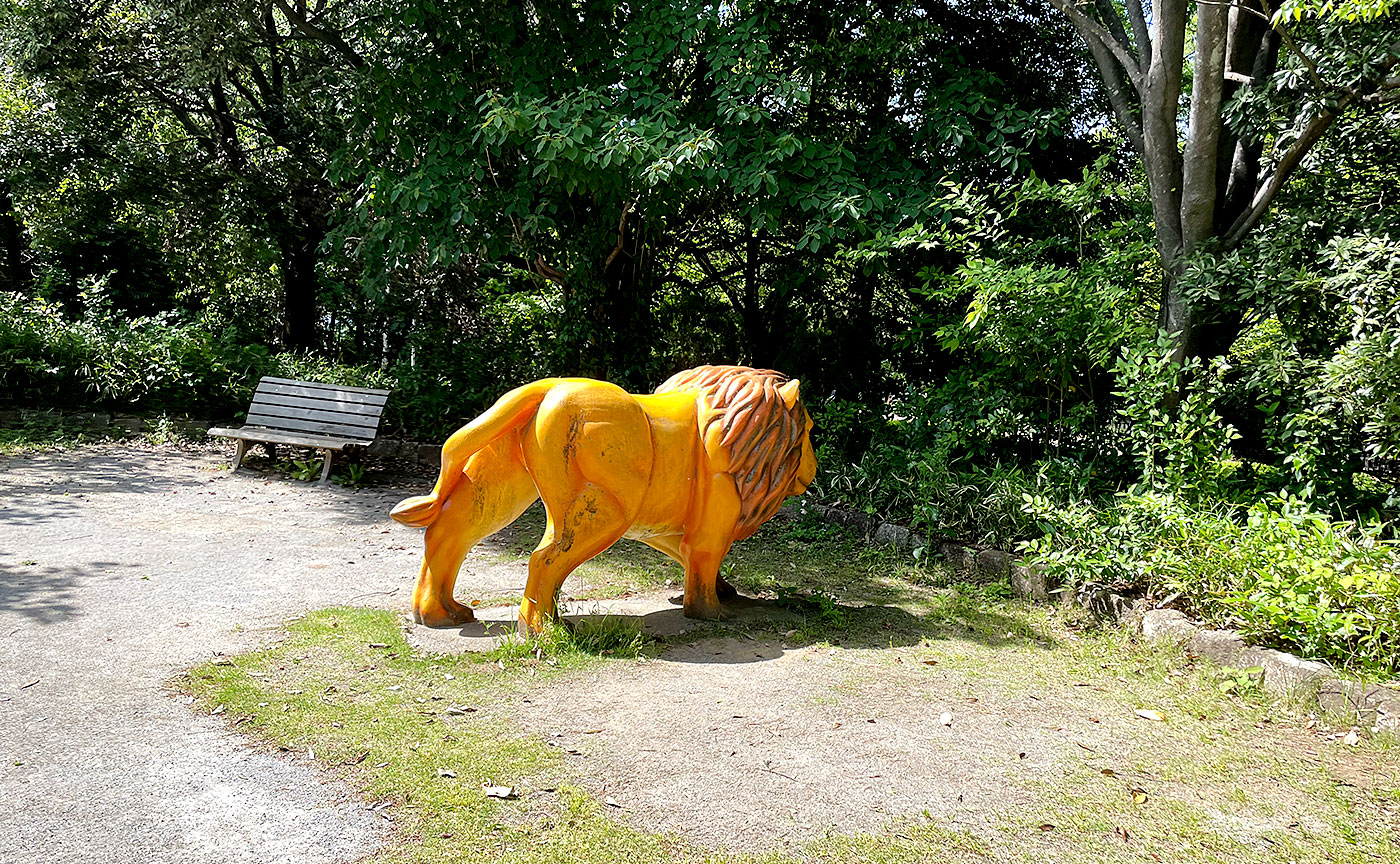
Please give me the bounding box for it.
[1051,0,1400,364]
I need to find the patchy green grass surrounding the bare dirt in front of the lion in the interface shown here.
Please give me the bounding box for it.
[179,524,1400,864]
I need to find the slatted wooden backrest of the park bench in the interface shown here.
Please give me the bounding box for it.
[246,378,389,444]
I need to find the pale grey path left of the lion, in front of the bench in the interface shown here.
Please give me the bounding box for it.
[0,447,498,864]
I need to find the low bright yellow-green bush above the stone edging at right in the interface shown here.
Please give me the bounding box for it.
[1021,492,1400,675]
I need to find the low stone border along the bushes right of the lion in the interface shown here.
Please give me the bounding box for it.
[784,500,1400,731]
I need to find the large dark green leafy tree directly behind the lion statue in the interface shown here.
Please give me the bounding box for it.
[333,0,1093,386]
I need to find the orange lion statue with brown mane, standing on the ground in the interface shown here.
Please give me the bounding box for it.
[392,365,816,633]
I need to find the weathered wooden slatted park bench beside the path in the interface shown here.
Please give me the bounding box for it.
[209,378,389,483]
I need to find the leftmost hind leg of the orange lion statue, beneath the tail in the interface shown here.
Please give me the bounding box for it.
[413,440,539,627]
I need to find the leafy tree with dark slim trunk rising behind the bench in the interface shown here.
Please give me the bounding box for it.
[4,0,358,349]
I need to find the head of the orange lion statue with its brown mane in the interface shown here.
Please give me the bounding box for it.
[657,365,816,541]
